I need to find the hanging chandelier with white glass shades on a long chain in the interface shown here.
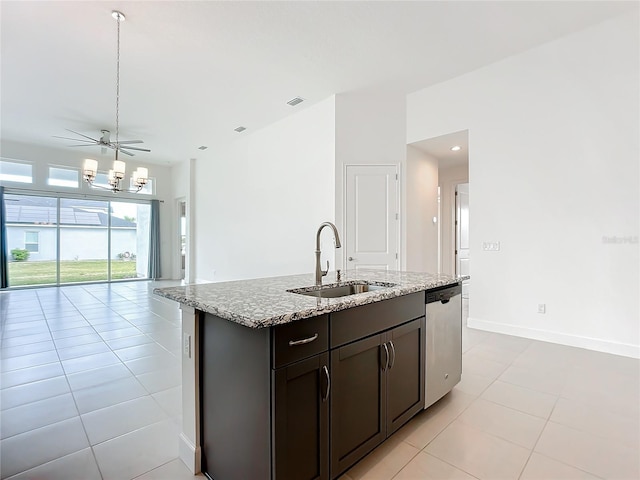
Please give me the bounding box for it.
[83,10,150,193]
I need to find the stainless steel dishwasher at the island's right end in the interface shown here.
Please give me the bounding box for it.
[424,284,462,408]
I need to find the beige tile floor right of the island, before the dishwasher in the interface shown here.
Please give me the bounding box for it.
[342,322,640,480]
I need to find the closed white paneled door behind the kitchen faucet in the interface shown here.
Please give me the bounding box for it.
[344,165,399,270]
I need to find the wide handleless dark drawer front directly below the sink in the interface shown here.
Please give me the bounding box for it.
[329,292,424,348]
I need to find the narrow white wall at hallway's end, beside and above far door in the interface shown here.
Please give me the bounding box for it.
[438,165,473,275]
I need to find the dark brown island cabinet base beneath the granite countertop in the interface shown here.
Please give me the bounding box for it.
[199,292,425,480]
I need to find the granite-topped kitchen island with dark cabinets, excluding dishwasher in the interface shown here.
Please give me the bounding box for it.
[154,270,463,480]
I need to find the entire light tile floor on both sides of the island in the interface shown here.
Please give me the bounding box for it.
[0,282,640,480]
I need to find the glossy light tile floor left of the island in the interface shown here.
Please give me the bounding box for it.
[0,282,203,480]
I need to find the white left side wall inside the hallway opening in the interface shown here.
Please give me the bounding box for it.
[403,145,439,273]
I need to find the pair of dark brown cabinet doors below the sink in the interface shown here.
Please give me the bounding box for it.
[330,317,425,478]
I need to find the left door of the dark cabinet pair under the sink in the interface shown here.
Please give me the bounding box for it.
[330,335,387,478]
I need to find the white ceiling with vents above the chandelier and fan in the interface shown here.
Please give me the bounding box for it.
[0,0,638,164]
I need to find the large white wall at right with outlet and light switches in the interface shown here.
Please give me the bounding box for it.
[407,13,640,357]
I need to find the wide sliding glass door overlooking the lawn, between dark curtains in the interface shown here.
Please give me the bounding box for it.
[5,193,150,287]
